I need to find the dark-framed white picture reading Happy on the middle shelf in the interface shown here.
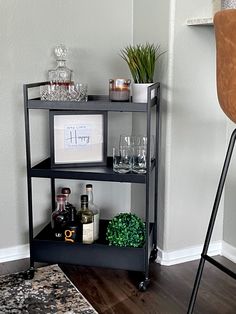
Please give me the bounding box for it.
[49,110,107,167]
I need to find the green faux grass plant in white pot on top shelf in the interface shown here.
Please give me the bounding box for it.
[120,43,162,102]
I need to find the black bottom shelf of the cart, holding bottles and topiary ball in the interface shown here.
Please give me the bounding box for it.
[31,220,154,272]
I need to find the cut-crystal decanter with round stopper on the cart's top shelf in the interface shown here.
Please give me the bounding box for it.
[48,45,72,86]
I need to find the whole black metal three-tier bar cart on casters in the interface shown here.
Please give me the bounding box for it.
[24,82,160,291]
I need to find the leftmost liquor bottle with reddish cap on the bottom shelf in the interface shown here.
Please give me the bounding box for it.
[51,194,67,240]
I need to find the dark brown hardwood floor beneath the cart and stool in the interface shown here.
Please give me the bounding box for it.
[60,257,236,314]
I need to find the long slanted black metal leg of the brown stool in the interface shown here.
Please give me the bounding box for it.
[187,129,236,314]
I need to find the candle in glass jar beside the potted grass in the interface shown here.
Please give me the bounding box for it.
[109,79,131,101]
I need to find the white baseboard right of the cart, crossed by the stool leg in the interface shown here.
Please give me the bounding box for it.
[157,241,222,266]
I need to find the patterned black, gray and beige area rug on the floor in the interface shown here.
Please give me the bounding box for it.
[0,265,98,314]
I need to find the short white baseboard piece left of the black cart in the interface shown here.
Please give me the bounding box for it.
[0,244,29,263]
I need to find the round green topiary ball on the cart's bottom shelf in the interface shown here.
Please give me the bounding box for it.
[106,213,145,247]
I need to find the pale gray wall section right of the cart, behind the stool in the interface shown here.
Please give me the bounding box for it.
[164,0,226,251]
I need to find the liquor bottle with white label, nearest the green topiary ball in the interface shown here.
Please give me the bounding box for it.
[79,195,94,244]
